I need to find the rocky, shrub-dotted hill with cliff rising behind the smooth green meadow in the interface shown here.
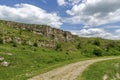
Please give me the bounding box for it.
[0,20,120,56]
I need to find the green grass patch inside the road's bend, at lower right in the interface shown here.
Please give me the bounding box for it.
[78,59,120,80]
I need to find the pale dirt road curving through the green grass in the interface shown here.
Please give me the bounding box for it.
[28,57,120,80]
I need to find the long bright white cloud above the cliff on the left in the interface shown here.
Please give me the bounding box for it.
[0,4,62,28]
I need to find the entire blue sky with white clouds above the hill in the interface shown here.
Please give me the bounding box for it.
[0,0,120,40]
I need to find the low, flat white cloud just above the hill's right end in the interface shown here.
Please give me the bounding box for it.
[71,28,120,40]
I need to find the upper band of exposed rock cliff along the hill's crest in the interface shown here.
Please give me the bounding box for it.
[0,21,73,41]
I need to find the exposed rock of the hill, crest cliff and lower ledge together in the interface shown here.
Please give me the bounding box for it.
[0,20,74,48]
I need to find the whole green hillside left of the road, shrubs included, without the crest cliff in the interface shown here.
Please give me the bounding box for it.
[0,21,120,80]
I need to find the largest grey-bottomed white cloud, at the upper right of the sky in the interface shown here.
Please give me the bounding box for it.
[64,0,120,26]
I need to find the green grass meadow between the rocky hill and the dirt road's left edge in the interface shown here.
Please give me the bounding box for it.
[0,44,88,80]
